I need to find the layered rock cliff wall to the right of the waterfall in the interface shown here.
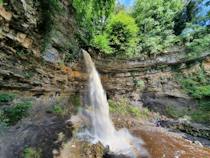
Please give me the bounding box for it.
[95,51,210,114]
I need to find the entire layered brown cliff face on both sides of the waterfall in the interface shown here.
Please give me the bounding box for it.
[0,0,210,112]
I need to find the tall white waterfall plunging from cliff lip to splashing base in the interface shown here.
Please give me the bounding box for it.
[80,51,146,158]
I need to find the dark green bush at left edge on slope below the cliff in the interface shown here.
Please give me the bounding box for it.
[0,101,32,125]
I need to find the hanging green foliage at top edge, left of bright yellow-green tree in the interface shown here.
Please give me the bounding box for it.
[73,0,115,40]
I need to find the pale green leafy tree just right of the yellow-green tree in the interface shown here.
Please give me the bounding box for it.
[132,0,184,55]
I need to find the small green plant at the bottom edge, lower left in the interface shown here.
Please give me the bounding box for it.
[23,147,41,158]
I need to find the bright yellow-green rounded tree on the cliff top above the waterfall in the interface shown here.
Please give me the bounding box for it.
[92,11,138,56]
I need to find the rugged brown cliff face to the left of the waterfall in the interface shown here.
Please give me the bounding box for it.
[0,0,84,96]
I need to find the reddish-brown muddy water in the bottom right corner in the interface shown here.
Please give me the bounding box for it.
[132,126,210,158]
